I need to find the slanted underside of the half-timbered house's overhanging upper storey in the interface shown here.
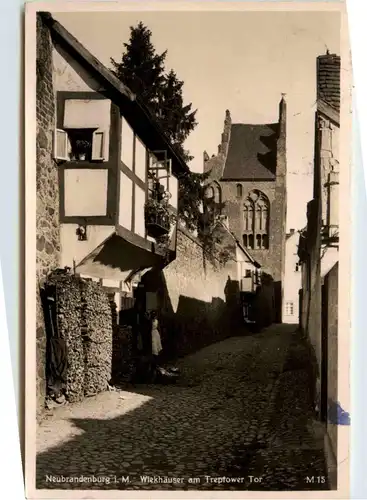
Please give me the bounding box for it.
[75,233,167,281]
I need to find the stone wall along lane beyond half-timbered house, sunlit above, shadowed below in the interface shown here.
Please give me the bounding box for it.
[144,228,243,357]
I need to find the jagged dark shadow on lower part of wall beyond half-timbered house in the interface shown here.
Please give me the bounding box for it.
[143,271,245,359]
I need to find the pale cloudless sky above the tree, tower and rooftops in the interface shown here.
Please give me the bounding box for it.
[53,11,340,230]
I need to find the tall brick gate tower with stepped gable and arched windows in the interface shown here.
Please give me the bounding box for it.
[204,95,287,322]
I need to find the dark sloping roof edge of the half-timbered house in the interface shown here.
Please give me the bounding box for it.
[38,12,189,173]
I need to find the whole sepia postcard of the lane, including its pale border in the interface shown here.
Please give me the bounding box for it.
[25,1,352,499]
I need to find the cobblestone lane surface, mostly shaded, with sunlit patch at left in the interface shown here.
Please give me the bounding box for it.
[36,325,327,490]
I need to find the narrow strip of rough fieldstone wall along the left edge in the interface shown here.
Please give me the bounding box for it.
[36,16,60,410]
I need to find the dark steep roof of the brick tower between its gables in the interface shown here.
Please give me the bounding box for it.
[222,123,279,181]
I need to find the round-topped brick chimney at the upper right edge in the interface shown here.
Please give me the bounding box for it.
[316,51,340,111]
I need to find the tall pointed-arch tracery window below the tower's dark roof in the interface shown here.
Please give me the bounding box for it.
[243,189,269,250]
